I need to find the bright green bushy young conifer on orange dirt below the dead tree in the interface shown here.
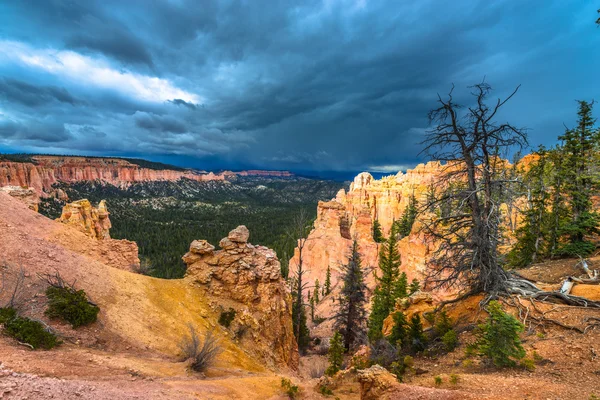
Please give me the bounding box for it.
[476,301,525,367]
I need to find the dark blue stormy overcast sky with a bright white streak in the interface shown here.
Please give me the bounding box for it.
[0,0,600,172]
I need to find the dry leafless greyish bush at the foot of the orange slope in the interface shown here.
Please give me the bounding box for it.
[179,325,223,372]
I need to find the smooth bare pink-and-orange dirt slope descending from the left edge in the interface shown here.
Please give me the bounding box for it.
[0,193,294,371]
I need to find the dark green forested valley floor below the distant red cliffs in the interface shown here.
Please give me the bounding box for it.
[40,177,347,278]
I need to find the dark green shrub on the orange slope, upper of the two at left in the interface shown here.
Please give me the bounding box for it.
[46,286,100,328]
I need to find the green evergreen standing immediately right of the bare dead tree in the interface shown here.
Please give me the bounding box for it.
[508,146,552,267]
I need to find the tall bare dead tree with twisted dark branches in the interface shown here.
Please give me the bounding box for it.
[424,82,527,297]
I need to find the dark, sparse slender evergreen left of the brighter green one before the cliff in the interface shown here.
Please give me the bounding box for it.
[334,240,367,350]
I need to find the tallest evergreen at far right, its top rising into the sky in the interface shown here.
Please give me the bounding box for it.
[559,101,600,256]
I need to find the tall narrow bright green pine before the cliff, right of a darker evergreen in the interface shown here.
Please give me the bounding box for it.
[368,226,400,342]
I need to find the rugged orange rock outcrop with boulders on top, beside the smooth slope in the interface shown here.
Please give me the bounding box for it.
[183,226,298,369]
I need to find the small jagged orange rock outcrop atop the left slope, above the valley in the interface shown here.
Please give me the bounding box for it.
[57,199,112,240]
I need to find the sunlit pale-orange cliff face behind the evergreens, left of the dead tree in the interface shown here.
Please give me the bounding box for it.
[290,162,442,300]
